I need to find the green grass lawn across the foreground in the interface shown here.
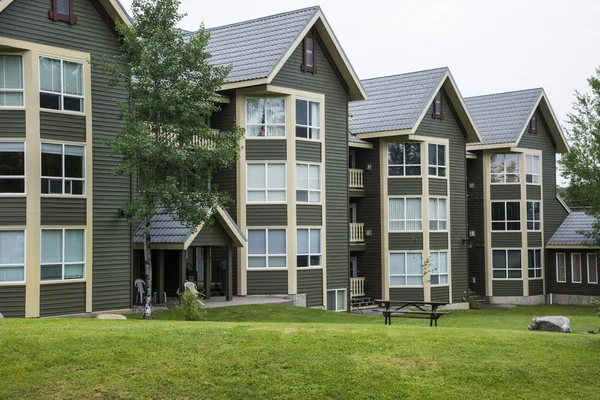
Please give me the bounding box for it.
[0,305,600,399]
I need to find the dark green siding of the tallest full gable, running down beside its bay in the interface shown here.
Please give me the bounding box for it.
[273,32,349,289]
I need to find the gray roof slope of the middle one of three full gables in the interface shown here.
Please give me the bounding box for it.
[349,67,448,134]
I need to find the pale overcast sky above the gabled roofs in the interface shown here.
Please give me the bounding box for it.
[122,0,600,130]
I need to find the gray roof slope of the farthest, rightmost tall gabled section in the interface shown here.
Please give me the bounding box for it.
[465,88,543,145]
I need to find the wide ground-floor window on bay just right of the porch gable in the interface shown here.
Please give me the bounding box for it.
[248,229,287,268]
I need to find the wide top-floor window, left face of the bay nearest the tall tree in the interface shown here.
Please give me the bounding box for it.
[246,98,285,137]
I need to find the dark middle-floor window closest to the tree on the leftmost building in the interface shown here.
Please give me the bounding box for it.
[42,143,85,195]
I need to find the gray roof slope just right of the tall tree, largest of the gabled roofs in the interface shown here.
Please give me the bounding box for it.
[206,6,320,82]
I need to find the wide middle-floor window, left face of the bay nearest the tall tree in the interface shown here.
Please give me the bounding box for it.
[247,164,286,202]
